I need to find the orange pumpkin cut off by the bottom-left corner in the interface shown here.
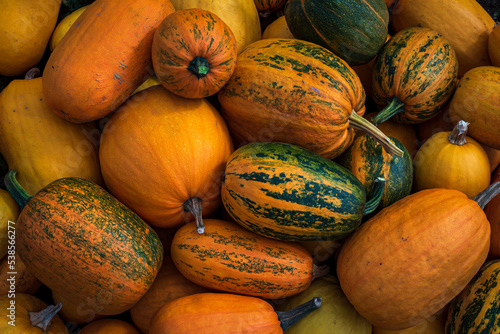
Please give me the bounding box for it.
[0,293,68,334]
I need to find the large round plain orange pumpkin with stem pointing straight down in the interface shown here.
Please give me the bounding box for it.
[99,86,233,232]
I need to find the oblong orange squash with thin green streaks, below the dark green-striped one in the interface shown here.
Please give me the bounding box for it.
[171,219,325,299]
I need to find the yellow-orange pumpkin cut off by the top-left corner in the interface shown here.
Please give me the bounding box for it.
[0,0,61,76]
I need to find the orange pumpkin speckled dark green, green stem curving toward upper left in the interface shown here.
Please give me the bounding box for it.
[6,171,163,315]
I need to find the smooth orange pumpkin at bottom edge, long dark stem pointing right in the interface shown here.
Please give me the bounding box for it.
[150,293,321,334]
